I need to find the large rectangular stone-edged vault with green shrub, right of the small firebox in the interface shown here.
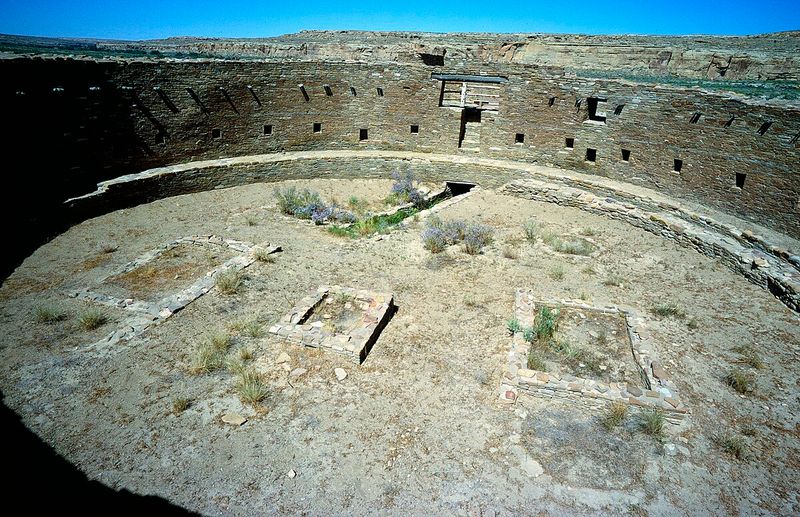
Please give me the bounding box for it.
[500,289,688,423]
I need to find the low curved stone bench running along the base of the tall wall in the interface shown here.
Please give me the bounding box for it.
[67,151,800,312]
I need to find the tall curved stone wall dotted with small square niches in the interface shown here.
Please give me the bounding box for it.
[0,58,800,242]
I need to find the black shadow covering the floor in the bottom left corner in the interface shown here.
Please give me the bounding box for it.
[0,391,196,515]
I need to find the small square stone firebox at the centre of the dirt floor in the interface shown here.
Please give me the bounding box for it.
[269,286,395,364]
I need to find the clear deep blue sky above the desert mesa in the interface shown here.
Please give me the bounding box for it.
[0,0,800,39]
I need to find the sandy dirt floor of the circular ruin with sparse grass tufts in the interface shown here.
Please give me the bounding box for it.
[0,176,800,515]
